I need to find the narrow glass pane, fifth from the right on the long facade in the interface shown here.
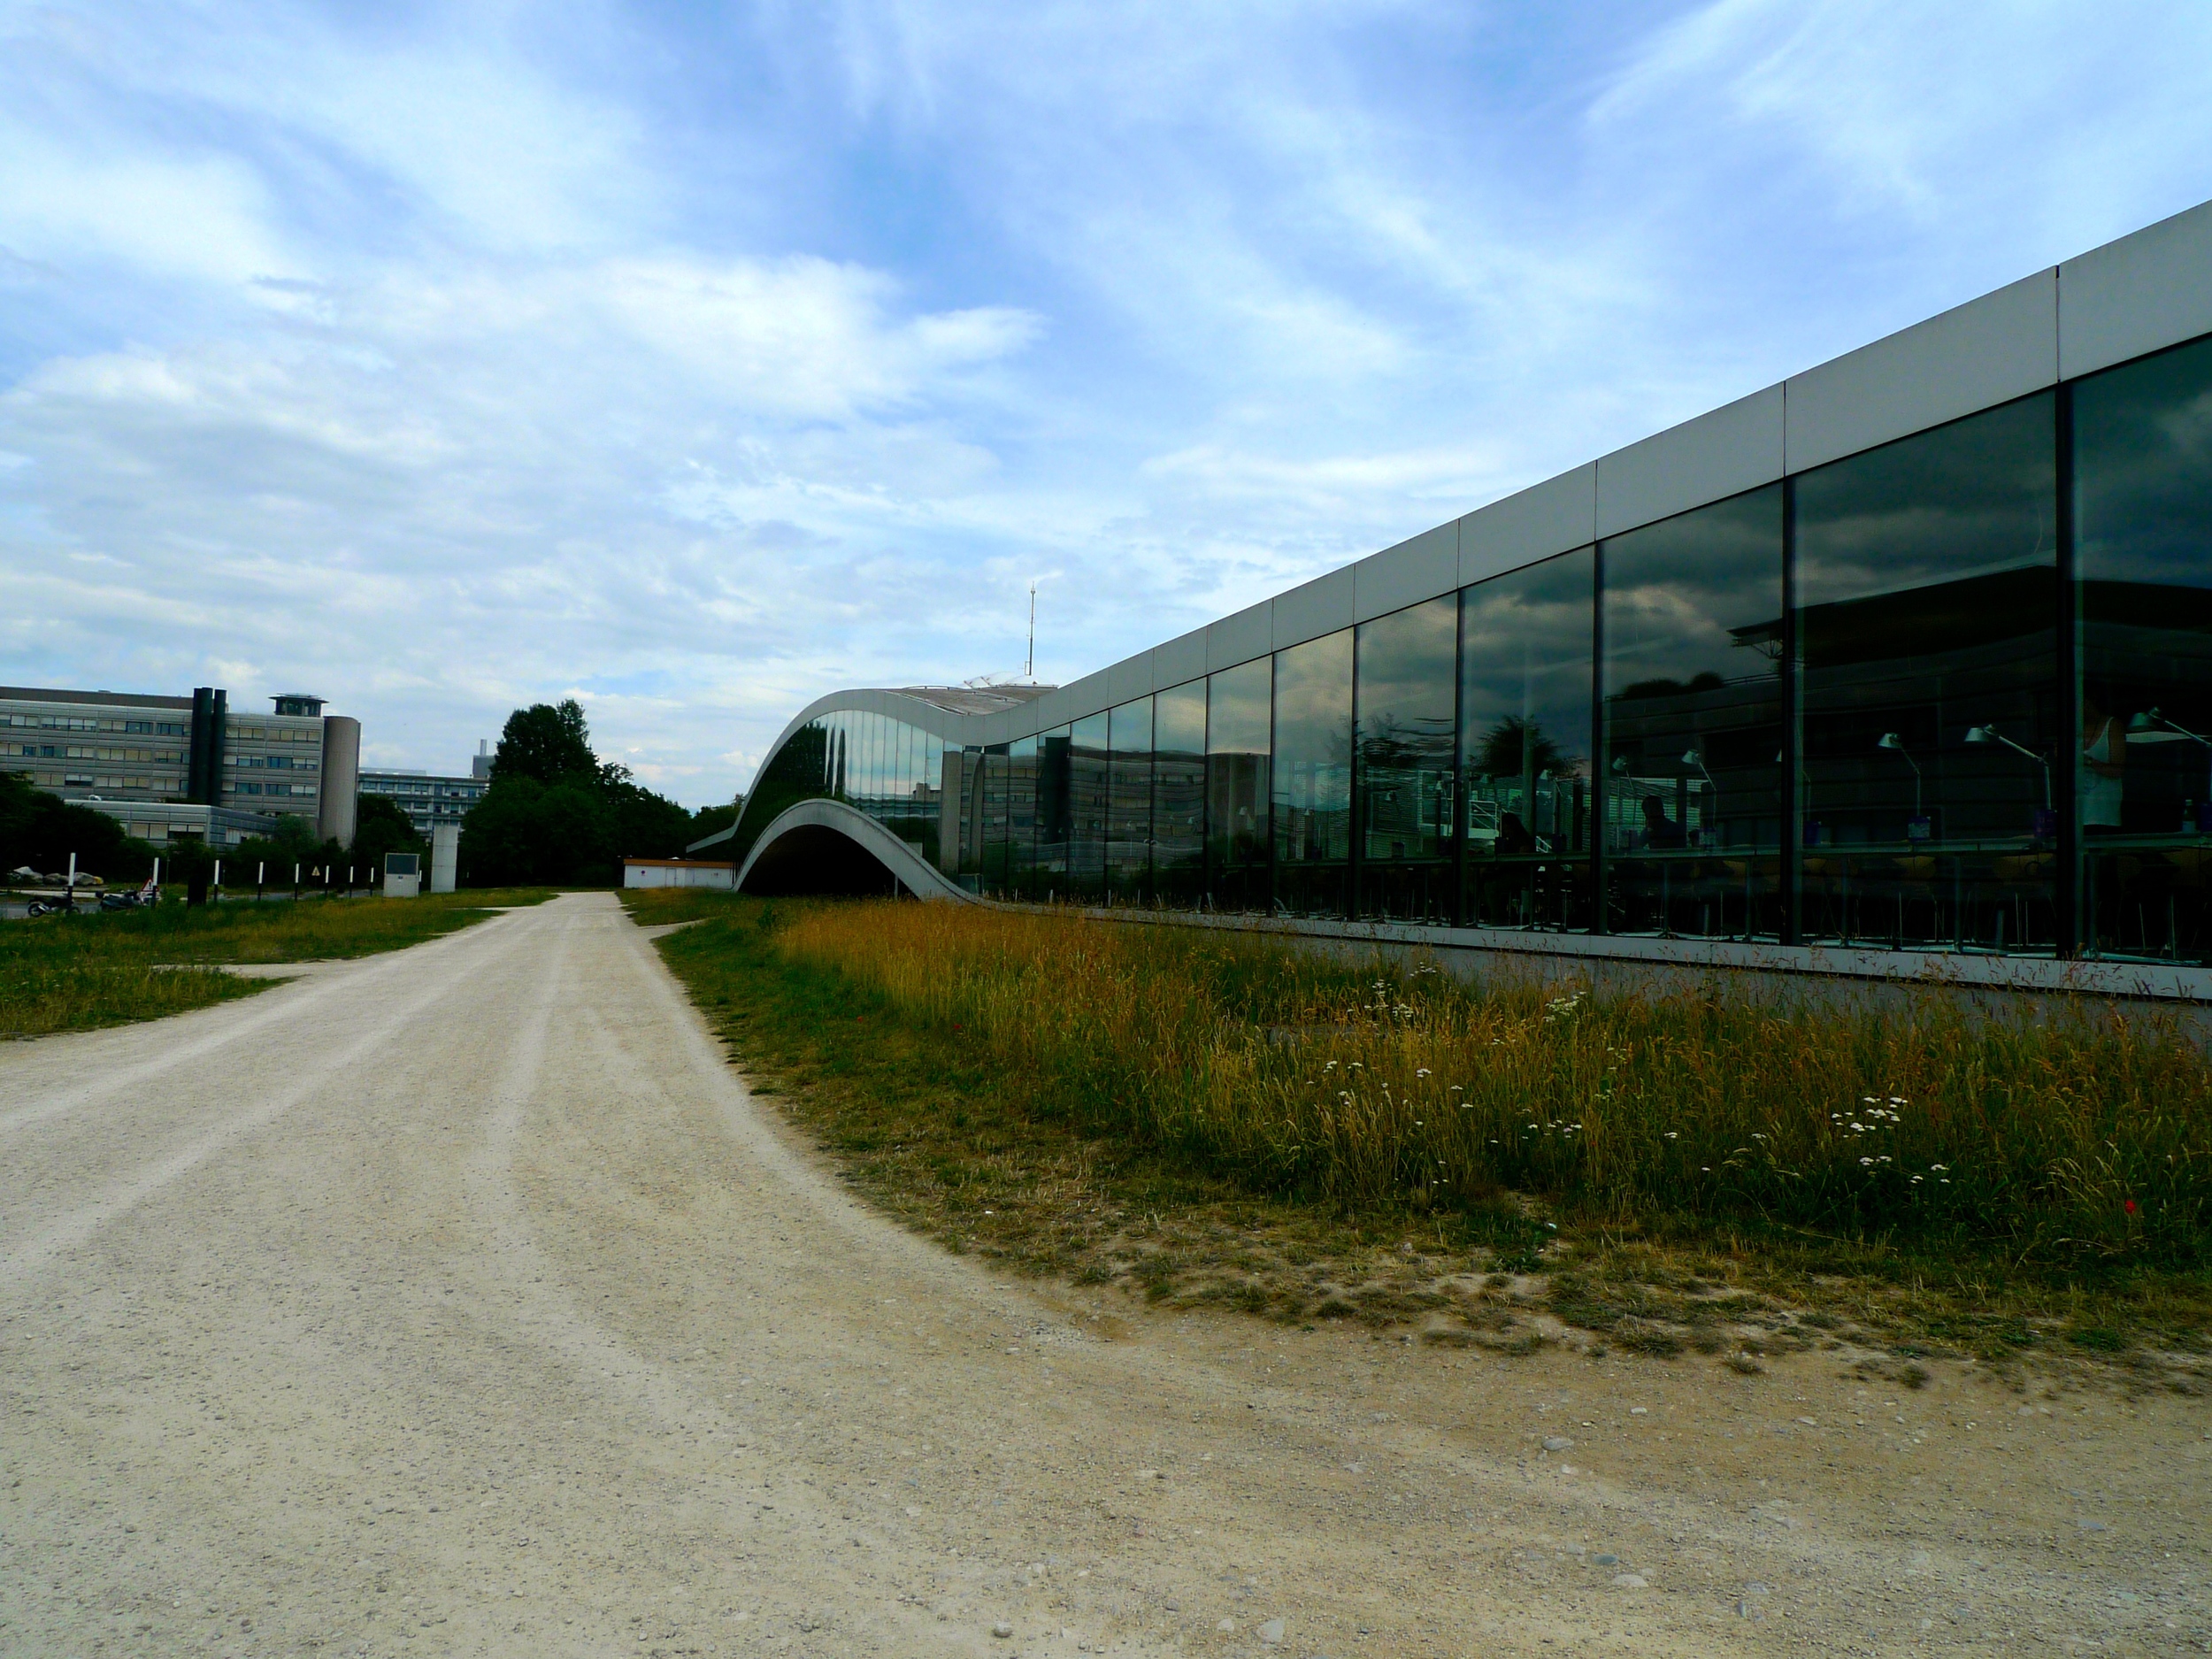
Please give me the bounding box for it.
[1356,593,1460,923]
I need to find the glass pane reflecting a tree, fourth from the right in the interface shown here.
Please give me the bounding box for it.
[1460,549,1597,929]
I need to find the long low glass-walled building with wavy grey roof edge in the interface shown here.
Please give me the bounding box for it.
[712,208,2212,964]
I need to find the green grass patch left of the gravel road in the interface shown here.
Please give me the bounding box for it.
[0,889,551,1038]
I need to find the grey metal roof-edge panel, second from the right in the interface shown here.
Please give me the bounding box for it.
[1786,270,2060,472]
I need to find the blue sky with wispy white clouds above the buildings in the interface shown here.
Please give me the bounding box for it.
[0,0,2212,805]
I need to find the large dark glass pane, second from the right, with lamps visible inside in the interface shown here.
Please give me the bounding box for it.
[1796,394,2060,951]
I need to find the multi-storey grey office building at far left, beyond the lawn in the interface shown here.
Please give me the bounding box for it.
[0,686,361,843]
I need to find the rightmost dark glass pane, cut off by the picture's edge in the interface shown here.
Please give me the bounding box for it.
[2075,341,2212,963]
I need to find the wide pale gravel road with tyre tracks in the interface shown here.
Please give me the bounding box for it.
[0,894,2212,1659]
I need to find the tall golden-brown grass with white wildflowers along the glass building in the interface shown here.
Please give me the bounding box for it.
[777,905,2212,1263]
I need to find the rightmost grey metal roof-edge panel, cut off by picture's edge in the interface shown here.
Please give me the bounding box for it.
[2060,202,2212,380]
